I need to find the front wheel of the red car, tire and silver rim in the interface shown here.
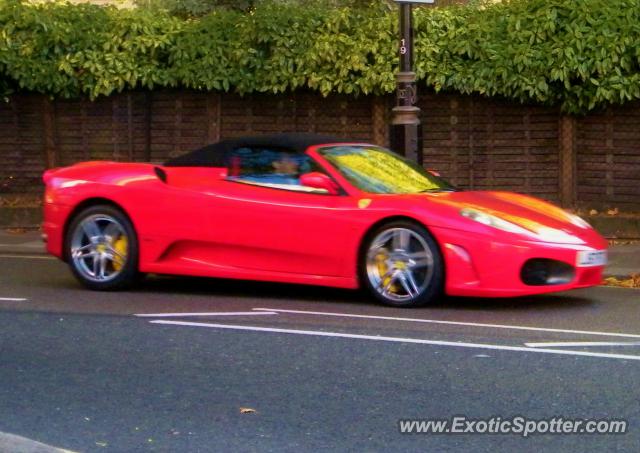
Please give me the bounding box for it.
[360,221,444,307]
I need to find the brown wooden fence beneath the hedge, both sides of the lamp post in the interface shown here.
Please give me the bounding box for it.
[0,91,640,210]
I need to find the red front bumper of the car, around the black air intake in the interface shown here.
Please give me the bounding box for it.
[431,227,607,297]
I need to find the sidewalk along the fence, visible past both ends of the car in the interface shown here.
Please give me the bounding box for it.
[0,230,640,278]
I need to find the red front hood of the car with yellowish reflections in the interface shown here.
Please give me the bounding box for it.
[408,191,602,243]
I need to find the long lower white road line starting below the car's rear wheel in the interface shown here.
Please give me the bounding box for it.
[149,320,640,360]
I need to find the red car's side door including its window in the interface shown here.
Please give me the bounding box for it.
[202,148,357,277]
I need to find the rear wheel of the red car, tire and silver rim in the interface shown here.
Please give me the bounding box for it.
[66,205,138,290]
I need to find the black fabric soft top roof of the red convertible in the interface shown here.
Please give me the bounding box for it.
[164,134,349,167]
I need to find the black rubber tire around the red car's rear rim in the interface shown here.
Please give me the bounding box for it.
[64,204,141,291]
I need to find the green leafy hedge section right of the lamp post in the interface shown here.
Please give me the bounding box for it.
[418,0,640,113]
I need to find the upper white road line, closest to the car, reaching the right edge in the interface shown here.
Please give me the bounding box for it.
[254,308,640,338]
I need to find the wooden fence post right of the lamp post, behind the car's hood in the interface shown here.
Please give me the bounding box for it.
[558,115,577,207]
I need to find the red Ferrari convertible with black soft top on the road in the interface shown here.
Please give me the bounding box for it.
[43,134,607,307]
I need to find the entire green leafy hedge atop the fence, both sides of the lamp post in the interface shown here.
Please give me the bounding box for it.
[0,0,640,113]
